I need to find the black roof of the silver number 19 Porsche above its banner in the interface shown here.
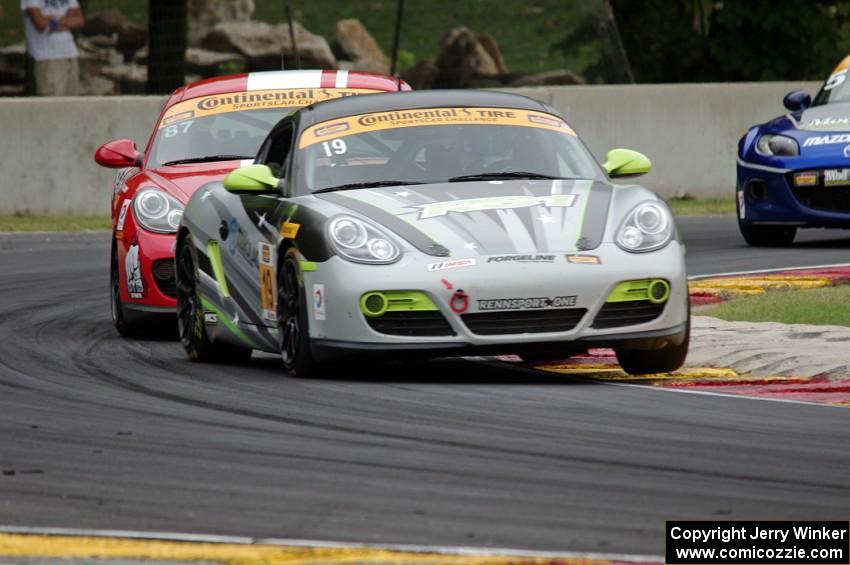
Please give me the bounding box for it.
[298,90,560,126]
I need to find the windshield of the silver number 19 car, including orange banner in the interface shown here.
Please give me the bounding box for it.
[298,107,604,192]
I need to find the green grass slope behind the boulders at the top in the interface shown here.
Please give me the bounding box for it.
[0,0,602,73]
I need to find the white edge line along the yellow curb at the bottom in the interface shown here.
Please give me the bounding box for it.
[0,526,664,563]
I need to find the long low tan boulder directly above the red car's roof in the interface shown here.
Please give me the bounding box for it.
[201,22,336,71]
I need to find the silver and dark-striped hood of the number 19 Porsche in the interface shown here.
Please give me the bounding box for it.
[312,180,613,257]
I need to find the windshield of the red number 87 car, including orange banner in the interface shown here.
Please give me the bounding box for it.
[147,88,377,168]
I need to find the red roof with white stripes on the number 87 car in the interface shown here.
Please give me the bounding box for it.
[169,69,410,106]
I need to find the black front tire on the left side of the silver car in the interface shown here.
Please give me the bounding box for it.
[277,248,319,378]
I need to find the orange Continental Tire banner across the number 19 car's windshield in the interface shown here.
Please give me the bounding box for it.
[298,108,576,149]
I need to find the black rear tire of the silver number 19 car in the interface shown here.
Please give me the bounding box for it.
[175,234,252,363]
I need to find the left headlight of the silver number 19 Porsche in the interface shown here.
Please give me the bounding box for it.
[328,216,401,264]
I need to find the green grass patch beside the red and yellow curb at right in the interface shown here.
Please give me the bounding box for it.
[699,286,850,326]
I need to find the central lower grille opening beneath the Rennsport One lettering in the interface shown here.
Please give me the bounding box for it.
[461,308,587,335]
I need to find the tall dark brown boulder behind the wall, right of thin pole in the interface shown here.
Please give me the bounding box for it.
[434,27,508,88]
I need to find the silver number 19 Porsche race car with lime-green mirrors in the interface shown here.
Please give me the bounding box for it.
[176,91,689,376]
